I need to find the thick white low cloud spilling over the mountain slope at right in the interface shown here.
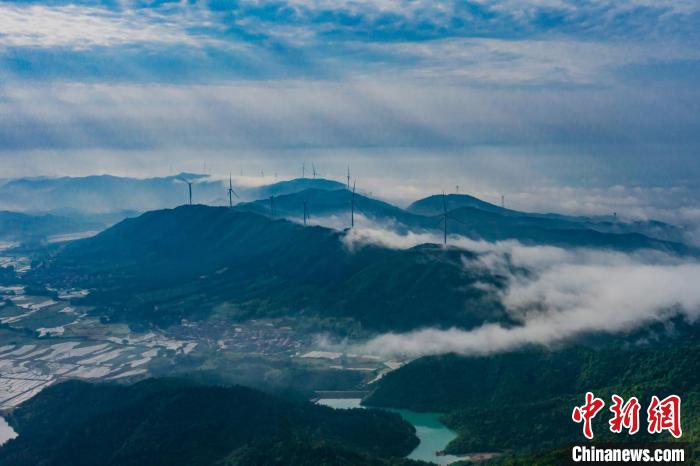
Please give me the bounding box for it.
[354,238,700,358]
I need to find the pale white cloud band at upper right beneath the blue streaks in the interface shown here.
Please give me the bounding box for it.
[361,37,700,86]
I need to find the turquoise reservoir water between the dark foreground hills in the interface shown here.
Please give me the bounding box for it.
[318,399,460,465]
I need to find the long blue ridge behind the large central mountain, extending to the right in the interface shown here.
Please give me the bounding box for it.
[236,189,688,253]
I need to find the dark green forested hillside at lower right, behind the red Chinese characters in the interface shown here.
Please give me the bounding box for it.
[365,346,700,460]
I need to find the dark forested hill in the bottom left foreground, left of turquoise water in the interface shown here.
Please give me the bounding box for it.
[0,379,418,466]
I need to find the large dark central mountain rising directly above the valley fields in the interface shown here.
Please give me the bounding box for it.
[27,206,503,330]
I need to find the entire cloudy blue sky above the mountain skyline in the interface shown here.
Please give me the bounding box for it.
[0,0,700,217]
